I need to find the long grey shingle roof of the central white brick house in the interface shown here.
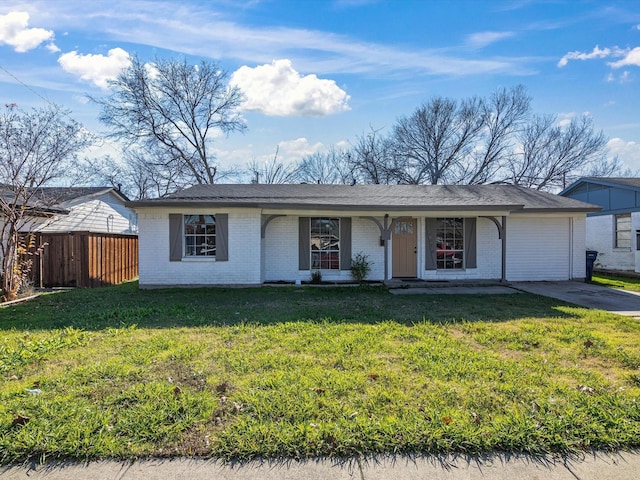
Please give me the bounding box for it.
[127,184,600,212]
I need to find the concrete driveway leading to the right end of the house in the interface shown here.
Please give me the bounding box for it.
[510,281,640,317]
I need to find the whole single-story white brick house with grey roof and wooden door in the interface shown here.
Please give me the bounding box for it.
[128,184,599,288]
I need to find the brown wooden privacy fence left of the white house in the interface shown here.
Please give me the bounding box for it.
[25,232,138,288]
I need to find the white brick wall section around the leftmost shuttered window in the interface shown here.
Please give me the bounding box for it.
[138,209,261,288]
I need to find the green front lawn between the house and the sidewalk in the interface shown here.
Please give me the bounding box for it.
[0,283,640,463]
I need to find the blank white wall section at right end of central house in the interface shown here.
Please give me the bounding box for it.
[507,215,572,281]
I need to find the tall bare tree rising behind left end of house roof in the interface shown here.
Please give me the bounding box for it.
[93,57,246,189]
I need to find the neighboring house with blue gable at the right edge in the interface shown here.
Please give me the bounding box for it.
[560,177,640,272]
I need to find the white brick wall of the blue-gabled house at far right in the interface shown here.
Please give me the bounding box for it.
[587,212,640,271]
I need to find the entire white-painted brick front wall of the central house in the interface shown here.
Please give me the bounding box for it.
[139,209,599,288]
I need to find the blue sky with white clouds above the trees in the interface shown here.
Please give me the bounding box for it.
[0,0,640,176]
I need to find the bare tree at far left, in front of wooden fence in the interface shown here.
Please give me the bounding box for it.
[0,105,93,300]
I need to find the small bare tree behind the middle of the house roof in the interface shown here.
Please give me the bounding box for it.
[295,146,355,184]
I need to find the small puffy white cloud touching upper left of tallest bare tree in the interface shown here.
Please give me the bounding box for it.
[58,48,131,89]
